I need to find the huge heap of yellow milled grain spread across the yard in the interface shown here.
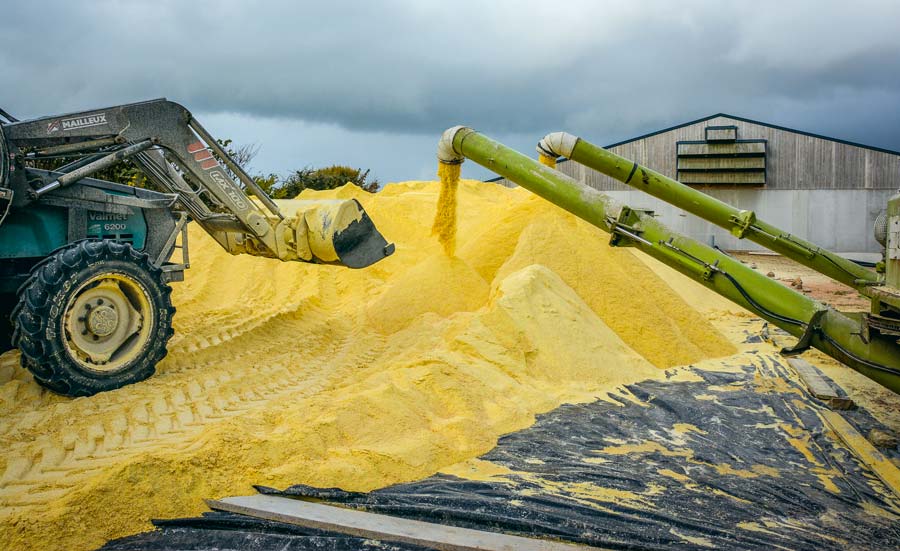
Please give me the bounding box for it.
[0,179,734,550]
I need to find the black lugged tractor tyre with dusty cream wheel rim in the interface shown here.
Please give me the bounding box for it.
[12,240,175,396]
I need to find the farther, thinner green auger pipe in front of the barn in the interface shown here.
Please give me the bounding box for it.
[538,132,880,294]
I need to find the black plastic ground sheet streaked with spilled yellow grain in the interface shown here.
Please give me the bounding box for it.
[104,354,900,551]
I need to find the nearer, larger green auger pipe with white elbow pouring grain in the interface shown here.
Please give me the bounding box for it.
[438,126,900,393]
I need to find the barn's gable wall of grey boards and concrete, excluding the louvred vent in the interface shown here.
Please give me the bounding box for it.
[497,116,900,252]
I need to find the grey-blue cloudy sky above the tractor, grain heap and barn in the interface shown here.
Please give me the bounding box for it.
[0,0,900,182]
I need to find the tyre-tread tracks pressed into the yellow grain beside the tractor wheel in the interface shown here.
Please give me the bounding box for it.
[0,282,383,518]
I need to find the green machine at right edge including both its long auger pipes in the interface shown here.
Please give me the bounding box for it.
[438,127,900,393]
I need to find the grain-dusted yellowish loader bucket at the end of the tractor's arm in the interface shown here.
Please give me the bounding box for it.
[278,199,394,268]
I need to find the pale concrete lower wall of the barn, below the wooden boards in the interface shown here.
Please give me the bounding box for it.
[604,189,894,253]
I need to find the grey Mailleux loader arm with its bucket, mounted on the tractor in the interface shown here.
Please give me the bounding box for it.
[4,99,393,268]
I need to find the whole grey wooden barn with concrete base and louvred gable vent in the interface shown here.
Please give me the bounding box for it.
[499,117,900,252]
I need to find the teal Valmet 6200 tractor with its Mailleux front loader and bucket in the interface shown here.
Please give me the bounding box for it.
[0,99,394,396]
